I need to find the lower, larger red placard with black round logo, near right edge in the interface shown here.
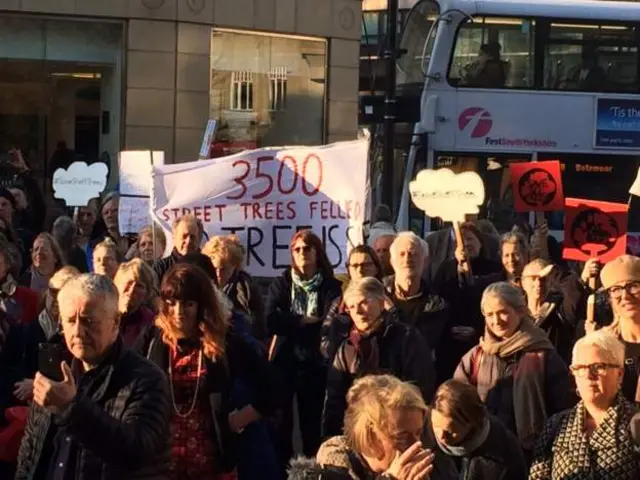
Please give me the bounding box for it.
[562,198,629,263]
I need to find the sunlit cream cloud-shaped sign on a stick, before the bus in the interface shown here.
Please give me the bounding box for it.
[409,168,485,222]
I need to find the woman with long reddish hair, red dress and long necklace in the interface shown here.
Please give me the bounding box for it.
[137,263,281,480]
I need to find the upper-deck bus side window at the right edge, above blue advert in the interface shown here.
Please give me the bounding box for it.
[544,23,638,92]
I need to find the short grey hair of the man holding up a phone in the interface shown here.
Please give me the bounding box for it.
[58,273,118,317]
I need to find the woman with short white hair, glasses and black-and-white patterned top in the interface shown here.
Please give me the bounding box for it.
[529,330,640,480]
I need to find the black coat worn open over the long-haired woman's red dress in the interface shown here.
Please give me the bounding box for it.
[134,325,283,472]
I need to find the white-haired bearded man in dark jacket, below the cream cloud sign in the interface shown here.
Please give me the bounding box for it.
[385,232,449,358]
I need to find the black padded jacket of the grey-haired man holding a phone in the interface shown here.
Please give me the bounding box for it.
[16,339,171,480]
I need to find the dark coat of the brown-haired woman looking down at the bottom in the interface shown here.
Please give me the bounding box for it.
[425,416,529,480]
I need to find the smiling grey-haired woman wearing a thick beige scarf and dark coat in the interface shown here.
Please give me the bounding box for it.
[454,282,573,455]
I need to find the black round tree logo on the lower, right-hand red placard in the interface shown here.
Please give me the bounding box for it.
[571,208,620,257]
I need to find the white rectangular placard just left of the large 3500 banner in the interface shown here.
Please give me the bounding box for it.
[118,150,164,234]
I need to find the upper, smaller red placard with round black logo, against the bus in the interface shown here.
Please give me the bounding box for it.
[509,160,564,212]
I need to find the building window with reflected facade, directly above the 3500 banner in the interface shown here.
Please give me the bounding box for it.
[209,28,327,157]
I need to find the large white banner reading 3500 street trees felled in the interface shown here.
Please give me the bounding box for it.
[152,139,369,277]
